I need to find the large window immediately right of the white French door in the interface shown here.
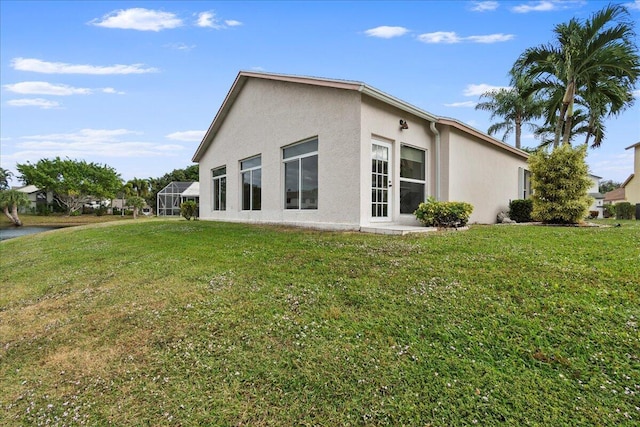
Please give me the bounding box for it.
[400,145,426,214]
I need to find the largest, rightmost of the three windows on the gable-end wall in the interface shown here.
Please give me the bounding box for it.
[282,139,318,209]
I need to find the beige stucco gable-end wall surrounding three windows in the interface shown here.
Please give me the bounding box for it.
[200,79,361,229]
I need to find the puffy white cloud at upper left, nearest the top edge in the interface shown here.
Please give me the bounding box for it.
[90,8,183,31]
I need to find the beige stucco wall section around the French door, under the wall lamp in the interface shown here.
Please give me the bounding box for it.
[360,96,435,226]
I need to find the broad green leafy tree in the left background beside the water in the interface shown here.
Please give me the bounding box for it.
[17,157,122,215]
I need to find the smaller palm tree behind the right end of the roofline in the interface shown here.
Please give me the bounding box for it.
[476,73,543,148]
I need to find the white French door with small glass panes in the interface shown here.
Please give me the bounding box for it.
[371,141,393,221]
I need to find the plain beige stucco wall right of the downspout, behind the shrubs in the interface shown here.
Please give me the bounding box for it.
[442,126,527,224]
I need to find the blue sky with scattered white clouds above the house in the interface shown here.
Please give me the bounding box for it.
[0,0,640,185]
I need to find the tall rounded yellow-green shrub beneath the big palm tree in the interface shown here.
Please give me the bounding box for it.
[529,144,593,224]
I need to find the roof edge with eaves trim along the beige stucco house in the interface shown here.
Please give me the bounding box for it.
[192,71,529,163]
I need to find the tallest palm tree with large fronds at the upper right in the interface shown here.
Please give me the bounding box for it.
[513,5,640,147]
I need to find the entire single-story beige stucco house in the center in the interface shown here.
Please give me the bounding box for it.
[193,72,530,230]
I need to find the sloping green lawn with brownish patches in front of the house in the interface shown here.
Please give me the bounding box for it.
[0,220,640,426]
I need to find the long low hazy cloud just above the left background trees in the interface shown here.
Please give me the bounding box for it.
[11,129,184,158]
